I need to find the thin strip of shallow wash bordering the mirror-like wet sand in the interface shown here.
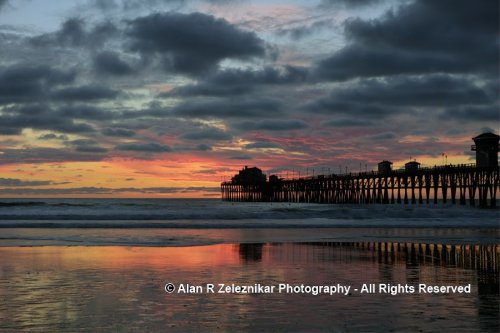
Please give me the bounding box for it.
[0,227,500,247]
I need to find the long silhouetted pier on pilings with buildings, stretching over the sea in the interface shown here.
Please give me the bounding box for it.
[221,133,500,207]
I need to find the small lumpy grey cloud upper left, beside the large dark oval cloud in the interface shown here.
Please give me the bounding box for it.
[30,18,119,47]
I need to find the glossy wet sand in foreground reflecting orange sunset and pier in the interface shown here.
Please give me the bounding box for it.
[0,242,500,332]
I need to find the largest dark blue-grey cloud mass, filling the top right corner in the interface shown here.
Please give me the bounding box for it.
[317,0,499,80]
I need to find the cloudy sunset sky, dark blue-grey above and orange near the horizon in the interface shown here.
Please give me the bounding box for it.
[0,0,500,198]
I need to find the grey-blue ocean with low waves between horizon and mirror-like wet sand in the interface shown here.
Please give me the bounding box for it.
[0,199,500,246]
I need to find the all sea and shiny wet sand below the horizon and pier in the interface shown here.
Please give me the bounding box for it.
[0,199,500,332]
